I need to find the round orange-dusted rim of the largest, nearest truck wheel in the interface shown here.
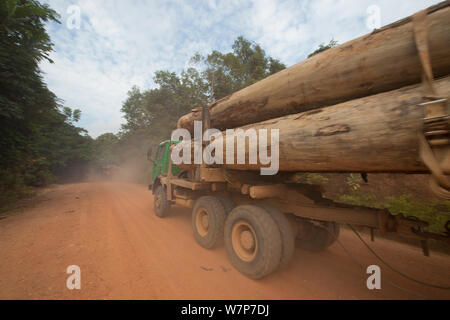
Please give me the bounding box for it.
[231,221,258,262]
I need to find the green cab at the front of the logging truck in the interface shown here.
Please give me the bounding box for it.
[147,140,181,192]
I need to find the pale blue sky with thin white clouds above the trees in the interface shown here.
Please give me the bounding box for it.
[41,0,440,138]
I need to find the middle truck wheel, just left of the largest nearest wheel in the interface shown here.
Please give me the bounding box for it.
[192,196,227,249]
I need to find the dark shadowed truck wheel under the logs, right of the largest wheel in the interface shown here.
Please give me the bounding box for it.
[295,221,340,252]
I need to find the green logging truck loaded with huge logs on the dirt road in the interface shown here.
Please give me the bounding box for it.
[148,1,450,279]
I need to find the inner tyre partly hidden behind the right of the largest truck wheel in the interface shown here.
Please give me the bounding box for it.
[261,206,295,268]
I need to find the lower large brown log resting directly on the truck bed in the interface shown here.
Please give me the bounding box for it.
[176,77,450,173]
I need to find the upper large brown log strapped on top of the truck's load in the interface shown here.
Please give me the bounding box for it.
[178,1,450,132]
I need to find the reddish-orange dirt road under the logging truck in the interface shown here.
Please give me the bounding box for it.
[0,182,450,299]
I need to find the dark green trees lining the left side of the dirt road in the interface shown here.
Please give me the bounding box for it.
[0,0,92,206]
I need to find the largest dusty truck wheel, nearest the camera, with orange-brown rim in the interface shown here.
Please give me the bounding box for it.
[225,205,282,279]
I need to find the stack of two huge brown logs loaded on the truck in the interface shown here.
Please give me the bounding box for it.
[174,1,450,173]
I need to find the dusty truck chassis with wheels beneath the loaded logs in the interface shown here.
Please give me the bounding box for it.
[149,161,448,279]
